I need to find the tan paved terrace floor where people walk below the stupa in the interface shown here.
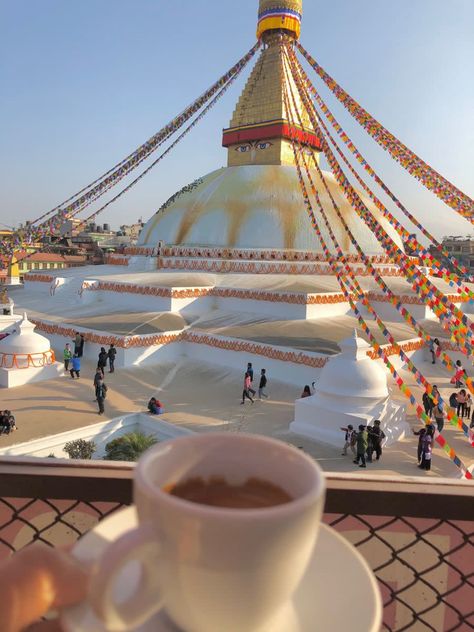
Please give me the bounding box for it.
[0,358,474,478]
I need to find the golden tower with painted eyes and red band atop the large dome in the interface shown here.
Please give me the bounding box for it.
[222,0,321,167]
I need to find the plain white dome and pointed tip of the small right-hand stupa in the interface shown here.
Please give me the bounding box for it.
[317,332,388,399]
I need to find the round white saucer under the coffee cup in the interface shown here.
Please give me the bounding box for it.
[61,507,382,632]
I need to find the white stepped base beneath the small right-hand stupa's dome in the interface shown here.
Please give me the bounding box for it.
[290,394,410,447]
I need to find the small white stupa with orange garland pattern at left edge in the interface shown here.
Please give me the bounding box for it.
[0,314,63,388]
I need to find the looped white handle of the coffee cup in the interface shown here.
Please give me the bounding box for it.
[89,523,163,632]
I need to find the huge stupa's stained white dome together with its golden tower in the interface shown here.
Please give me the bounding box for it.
[138,0,403,257]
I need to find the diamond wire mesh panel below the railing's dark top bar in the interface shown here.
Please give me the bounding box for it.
[0,498,474,632]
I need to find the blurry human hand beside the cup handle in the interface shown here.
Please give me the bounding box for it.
[0,544,88,632]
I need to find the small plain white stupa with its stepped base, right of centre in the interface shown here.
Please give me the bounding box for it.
[290,331,408,447]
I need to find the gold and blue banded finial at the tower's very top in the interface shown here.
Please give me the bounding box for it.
[257,0,303,39]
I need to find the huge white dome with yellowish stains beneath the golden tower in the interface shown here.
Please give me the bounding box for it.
[138,165,403,255]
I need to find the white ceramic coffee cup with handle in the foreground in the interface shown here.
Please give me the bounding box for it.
[89,433,325,632]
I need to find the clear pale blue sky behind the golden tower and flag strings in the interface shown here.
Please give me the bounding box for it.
[0,0,474,236]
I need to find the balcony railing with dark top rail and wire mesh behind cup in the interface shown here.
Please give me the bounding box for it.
[0,458,474,632]
